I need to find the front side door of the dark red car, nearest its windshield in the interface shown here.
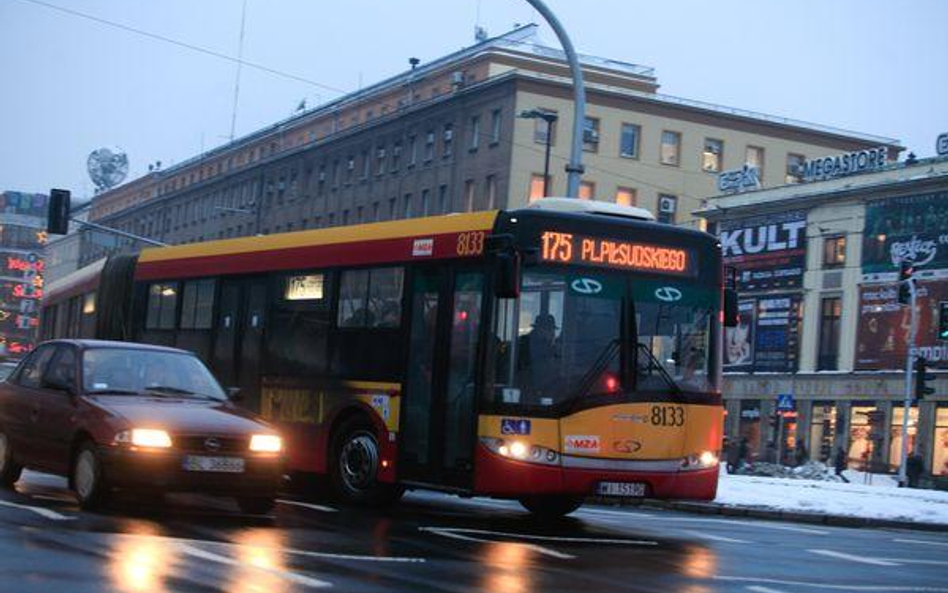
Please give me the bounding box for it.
[31,344,78,473]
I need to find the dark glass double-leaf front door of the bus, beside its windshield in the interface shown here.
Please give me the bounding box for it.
[399,267,484,488]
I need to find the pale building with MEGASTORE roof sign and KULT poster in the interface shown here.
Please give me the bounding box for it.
[698,151,948,485]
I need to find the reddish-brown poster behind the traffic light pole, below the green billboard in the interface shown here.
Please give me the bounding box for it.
[855,280,948,371]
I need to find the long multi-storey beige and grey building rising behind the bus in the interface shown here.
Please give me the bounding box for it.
[83,25,899,262]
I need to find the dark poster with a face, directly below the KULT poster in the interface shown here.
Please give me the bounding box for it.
[724,294,802,373]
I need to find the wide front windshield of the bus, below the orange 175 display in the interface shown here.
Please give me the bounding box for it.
[494,268,717,409]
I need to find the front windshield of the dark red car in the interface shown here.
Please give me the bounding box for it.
[82,348,226,400]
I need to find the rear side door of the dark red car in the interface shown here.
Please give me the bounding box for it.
[0,344,56,466]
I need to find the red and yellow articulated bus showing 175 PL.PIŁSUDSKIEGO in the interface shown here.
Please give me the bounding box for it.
[41,198,725,515]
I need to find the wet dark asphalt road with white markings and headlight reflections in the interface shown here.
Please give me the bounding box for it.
[0,472,948,593]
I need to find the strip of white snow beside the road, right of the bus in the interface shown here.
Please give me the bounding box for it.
[714,471,948,525]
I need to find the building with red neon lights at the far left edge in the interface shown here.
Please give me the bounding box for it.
[0,191,48,358]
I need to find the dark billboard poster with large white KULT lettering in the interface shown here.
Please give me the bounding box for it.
[718,210,806,293]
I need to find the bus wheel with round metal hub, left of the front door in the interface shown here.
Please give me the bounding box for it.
[329,416,403,507]
